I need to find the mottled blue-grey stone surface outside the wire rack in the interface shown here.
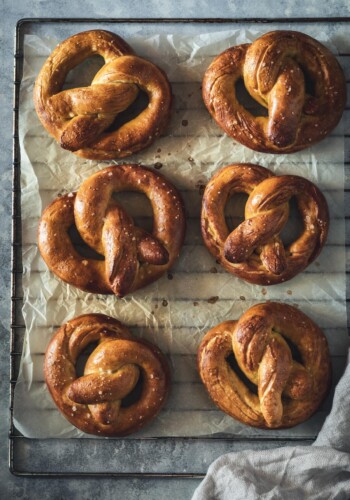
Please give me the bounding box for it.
[0,0,350,500]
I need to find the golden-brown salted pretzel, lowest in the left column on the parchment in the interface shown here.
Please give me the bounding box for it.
[44,314,170,436]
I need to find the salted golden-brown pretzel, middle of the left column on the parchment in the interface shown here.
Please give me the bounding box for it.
[38,165,185,297]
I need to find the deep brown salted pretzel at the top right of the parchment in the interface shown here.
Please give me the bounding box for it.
[203,31,346,153]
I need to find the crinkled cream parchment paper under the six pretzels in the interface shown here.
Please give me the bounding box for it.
[14,30,348,438]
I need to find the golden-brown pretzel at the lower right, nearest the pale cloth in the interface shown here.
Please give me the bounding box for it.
[198,302,331,429]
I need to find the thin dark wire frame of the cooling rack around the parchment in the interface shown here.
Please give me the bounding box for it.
[9,18,350,478]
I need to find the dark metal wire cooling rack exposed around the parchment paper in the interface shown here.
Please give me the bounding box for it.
[9,18,350,478]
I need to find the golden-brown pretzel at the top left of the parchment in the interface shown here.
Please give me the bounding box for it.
[34,30,172,160]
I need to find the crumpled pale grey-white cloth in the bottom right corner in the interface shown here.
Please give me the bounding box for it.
[192,358,350,500]
